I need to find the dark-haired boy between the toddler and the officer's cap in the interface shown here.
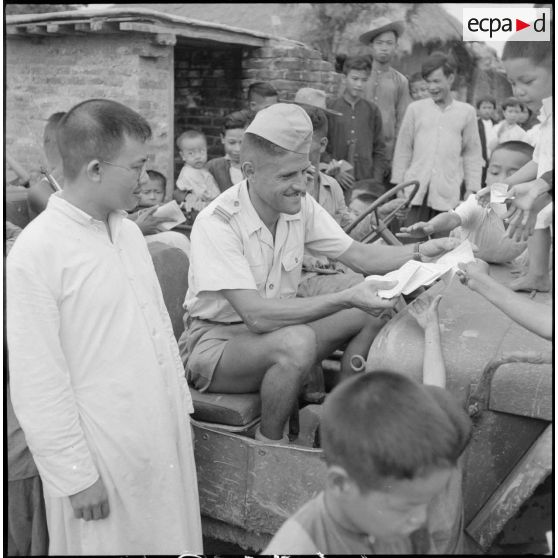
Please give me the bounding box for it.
[207,109,251,192]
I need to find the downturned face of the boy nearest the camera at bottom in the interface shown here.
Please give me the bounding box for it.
[340,469,453,540]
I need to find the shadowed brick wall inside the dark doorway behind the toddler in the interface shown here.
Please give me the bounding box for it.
[174,45,244,176]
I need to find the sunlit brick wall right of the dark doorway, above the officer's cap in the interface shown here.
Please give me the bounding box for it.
[242,41,341,101]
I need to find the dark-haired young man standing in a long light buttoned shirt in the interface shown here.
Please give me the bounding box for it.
[391,52,482,226]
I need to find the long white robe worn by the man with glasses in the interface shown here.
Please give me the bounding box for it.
[7,194,203,554]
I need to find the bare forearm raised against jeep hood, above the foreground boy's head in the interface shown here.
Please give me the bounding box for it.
[408,295,446,389]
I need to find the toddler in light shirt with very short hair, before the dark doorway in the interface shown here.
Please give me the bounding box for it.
[174,130,221,220]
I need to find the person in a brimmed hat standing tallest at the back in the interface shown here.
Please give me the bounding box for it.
[359,17,411,173]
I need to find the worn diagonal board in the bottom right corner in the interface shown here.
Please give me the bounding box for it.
[465,424,553,551]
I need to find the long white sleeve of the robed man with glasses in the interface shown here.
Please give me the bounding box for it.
[6,249,99,497]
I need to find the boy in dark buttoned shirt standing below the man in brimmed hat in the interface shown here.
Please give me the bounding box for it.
[328,56,386,189]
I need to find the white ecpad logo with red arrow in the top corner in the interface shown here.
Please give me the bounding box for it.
[463,7,551,41]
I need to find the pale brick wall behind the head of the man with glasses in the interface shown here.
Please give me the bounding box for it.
[5,34,174,195]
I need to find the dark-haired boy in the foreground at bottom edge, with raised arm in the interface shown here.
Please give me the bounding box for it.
[263,297,471,555]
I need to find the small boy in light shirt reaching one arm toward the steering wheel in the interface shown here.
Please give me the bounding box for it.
[397,141,533,263]
